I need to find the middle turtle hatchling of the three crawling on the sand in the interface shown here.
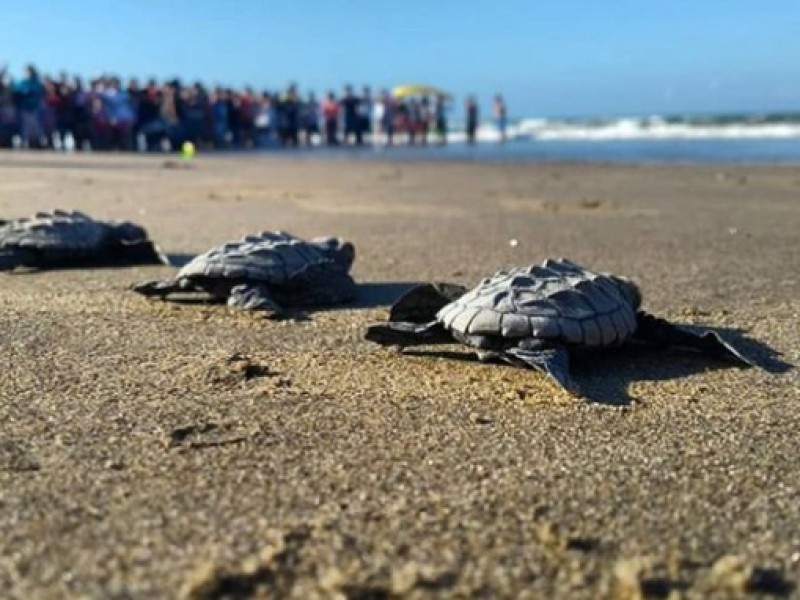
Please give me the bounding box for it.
[132,231,356,314]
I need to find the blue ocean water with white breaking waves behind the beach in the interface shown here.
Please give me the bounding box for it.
[260,113,800,165]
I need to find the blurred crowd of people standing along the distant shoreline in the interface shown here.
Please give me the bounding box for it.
[0,65,505,151]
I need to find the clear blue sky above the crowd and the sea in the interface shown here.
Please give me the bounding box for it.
[0,0,800,117]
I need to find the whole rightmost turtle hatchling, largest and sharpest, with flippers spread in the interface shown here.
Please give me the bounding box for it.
[366,259,751,393]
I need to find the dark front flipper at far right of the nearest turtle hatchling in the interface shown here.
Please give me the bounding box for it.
[634,312,754,367]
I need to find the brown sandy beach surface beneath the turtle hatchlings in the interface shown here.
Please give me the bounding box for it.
[0,154,800,600]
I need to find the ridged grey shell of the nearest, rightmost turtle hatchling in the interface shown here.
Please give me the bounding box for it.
[436,259,638,347]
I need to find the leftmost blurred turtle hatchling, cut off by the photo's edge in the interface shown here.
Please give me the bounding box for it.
[0,210,169,271]
